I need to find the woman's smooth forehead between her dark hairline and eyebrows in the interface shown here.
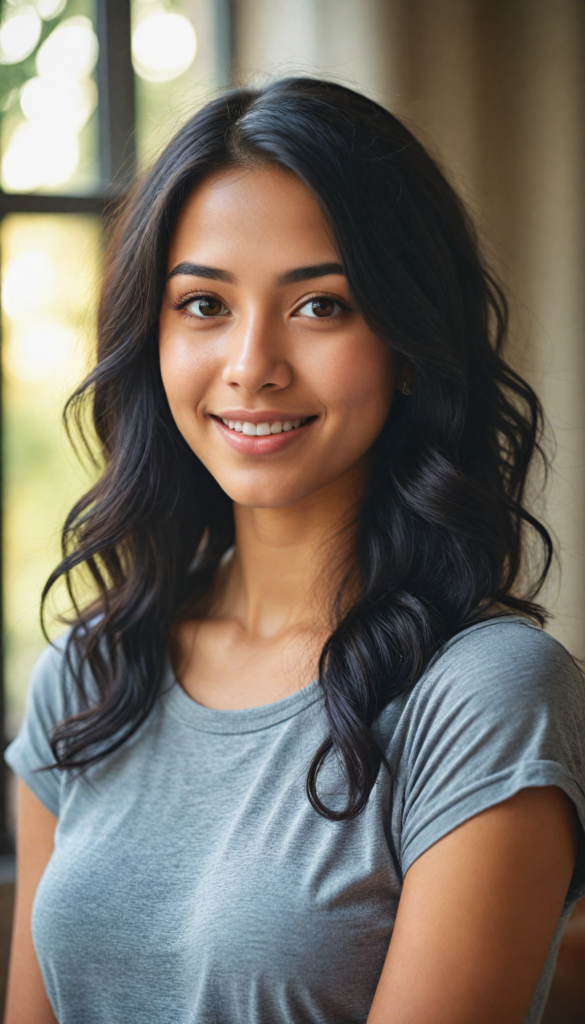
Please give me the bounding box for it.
[168,166,338,268]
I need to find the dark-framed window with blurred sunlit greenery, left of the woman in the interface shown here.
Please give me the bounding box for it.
[0,0,231,852]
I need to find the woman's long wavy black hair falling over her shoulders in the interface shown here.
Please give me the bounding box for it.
[43,78,552,820]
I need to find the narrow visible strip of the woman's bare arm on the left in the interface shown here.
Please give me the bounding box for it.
[4,781,57,1024]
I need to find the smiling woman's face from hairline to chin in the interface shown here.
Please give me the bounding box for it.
[160,167,395,507]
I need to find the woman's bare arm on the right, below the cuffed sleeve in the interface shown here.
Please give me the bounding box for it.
[368,785,577,1024]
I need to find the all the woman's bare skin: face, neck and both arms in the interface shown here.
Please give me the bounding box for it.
[5,167,576,1024]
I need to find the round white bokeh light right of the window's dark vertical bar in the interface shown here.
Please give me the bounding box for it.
[132,11,197,82]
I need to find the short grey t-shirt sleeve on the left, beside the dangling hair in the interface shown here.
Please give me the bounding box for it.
[4,640,70,817]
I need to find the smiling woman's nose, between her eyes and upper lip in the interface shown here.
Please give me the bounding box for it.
[222,312,293,394]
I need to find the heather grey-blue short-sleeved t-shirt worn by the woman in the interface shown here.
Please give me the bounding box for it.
[6,618,585,1024]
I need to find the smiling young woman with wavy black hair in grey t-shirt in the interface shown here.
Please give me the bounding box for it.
[6,79,585,1024]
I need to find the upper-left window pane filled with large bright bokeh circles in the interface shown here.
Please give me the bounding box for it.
[0,0,99,195]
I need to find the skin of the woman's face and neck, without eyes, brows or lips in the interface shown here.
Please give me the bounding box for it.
[160,168,402,708]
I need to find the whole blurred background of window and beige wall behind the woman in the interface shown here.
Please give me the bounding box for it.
[0,0,585,1024]
